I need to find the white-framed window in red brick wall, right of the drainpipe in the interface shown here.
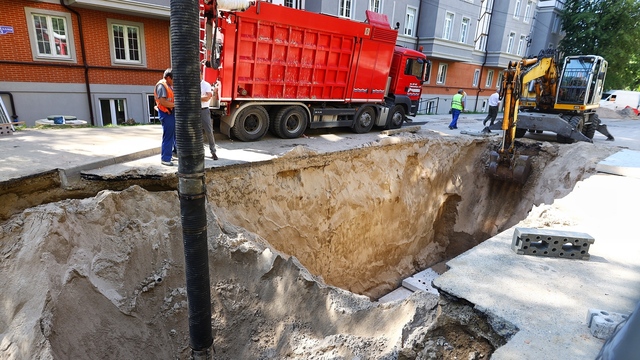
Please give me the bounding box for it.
[107,19,146,65]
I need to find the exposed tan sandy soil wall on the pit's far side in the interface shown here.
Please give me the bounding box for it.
[207,136,609,298]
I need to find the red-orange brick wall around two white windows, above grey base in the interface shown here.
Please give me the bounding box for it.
[0,0,171,85]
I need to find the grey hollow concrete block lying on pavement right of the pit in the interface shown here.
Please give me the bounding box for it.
[511,228,595,260]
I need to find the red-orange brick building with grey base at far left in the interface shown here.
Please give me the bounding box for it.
[0,0,171,126]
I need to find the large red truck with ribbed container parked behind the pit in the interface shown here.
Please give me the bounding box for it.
[201,1,429,141]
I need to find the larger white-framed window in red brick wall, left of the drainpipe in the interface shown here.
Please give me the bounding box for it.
[25,8,76,62]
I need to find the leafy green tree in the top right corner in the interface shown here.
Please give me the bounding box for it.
[558,0,640,90]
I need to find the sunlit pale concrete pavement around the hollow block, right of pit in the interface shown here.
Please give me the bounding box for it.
[434,174,640,360]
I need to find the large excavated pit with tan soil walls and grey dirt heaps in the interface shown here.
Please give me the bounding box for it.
[0,136,620,359]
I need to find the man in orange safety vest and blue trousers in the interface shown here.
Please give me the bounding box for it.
[153,68,176,166]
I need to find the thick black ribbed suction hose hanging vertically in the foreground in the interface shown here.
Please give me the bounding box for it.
[170,0,213,360]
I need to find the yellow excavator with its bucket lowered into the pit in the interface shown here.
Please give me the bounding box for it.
[484,49,613,184]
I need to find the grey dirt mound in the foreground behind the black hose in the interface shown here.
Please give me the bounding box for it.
[0,186,464,359]
